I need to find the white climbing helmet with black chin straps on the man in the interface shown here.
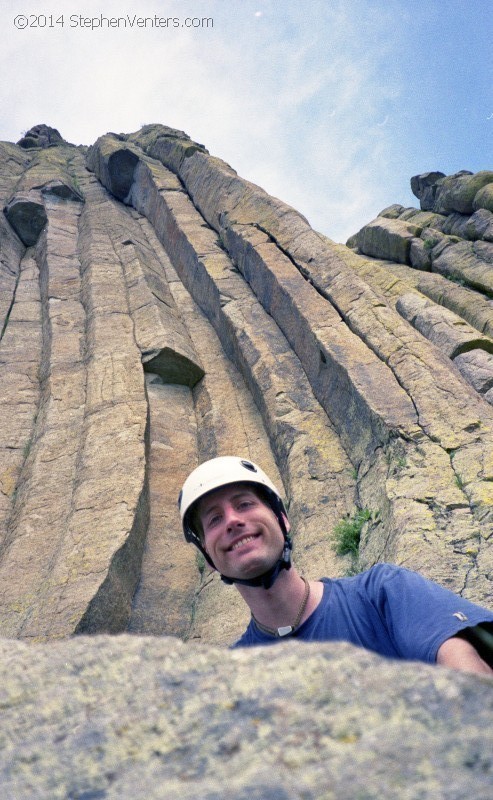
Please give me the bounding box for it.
[178,456,292,586]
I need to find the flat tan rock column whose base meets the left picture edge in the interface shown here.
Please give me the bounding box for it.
[0,183,85,636]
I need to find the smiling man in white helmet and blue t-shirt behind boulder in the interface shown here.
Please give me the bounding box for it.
[179,456,493,675]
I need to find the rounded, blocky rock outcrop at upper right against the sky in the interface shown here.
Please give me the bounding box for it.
[348,171,493,404]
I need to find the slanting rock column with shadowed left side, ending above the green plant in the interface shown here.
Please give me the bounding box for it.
[225,226,415,461]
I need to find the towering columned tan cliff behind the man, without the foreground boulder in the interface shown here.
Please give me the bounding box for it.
[0,125,493,644]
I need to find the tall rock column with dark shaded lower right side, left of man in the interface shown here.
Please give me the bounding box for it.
[51,165,148,635]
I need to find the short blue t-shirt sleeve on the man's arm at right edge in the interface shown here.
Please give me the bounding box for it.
[371,564,493,663]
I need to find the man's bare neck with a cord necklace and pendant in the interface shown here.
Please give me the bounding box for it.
[236,567,323,630]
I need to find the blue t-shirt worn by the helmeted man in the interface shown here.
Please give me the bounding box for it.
[233,564,493,663]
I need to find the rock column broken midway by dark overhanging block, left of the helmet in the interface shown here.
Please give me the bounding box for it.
[95,192,204,636]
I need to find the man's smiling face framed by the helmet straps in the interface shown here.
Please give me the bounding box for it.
[198,484,289,578]
